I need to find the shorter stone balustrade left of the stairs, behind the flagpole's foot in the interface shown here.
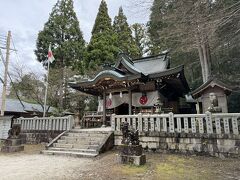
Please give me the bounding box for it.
[14,116,74,131]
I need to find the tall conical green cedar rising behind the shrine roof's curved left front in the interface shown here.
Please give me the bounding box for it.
[86,0,117,70]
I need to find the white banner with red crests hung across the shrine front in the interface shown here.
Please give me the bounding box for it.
[98,91,159,112]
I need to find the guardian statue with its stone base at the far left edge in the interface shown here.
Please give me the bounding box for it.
[1,124,24,152]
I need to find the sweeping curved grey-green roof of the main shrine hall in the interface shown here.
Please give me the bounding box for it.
[69,51,189,96]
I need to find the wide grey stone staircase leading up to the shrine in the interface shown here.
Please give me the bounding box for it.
[41,128,114,157]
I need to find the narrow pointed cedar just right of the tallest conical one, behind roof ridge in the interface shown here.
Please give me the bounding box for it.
[113,7,141,58]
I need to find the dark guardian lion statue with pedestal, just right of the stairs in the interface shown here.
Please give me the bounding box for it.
[118,121,146,166]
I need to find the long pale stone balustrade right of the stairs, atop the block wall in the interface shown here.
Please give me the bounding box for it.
[111,112,240,135]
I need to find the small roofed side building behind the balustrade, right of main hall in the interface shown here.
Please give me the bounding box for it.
[191,77,232,114]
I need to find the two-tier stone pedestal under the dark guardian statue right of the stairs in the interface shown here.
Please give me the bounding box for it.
[117,145,146,166]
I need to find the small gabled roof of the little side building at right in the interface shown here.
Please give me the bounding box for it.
[191,77,232,97]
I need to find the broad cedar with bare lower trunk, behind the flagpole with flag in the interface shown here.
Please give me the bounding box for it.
[35,0,85,110]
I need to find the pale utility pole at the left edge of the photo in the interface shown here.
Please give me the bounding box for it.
[1,31,11,116]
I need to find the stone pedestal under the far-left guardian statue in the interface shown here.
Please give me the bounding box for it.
[1,139,24,153]
